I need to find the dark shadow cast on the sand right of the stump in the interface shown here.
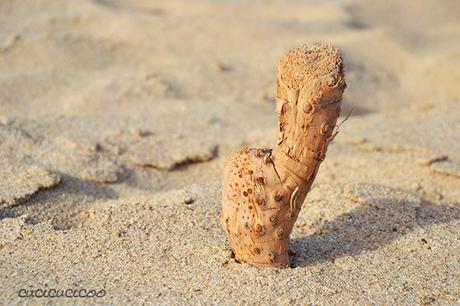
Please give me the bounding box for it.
[290,191,460,267]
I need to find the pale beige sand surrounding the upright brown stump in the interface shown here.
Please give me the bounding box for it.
[0,0,460,305]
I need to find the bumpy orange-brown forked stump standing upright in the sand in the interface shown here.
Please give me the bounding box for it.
[221,45,346,268]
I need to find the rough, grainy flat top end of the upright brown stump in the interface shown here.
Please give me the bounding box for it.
[278,44,343,89]
